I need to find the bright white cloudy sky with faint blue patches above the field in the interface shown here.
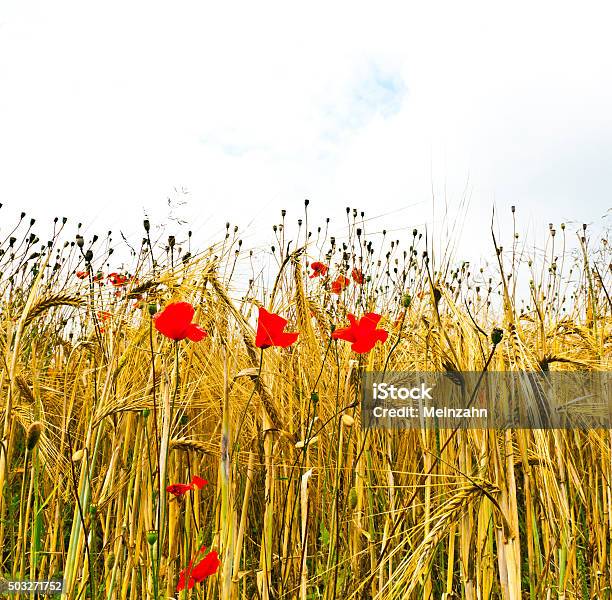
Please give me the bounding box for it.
[0,0,612,264]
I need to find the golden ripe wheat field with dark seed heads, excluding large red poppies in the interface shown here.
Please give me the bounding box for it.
[0,209,612,600]
